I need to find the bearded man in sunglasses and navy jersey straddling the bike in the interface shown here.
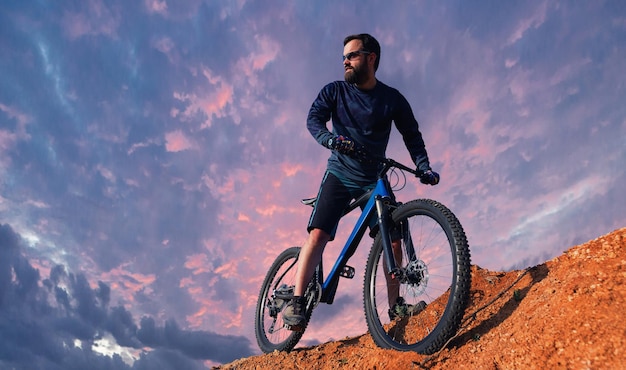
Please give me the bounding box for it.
[283,34,439,331]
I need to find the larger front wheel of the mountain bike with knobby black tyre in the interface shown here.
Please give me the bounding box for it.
[363,199,471,354]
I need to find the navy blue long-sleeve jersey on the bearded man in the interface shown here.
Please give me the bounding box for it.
[307,80,430,183]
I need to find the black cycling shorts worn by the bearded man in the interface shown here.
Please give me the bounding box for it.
[307,171,376,240]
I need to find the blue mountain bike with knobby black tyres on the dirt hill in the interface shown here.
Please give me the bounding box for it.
[255,158,470,354]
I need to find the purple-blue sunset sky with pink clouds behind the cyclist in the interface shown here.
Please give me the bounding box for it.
[0,0,626,369]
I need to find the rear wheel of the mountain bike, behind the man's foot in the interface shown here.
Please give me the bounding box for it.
[254,247,310,353]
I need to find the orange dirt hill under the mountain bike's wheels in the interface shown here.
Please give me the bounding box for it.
[218,228,626,370]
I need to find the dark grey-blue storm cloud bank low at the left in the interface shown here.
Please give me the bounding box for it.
[0,224,252,369]
